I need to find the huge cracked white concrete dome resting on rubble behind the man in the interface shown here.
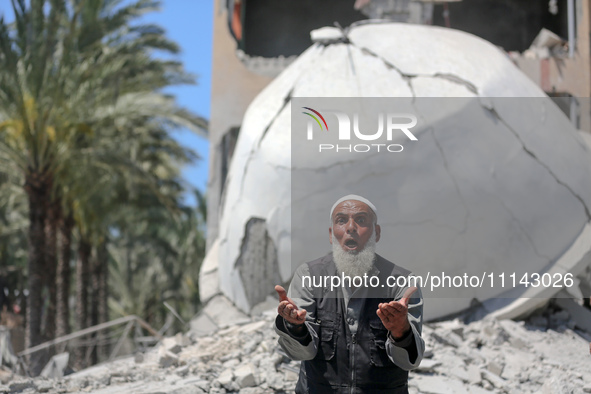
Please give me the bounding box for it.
[200,23,591,319]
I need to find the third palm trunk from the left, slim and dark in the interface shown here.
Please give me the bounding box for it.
[75,237,91,368]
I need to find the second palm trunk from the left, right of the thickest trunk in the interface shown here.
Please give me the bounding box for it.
[56,214,74,337]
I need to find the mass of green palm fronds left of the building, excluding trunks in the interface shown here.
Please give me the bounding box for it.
[0,0,207,338]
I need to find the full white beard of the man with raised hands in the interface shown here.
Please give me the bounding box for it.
[332,231,376,278]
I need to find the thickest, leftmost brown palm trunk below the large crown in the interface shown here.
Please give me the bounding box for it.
[24,172,51,373]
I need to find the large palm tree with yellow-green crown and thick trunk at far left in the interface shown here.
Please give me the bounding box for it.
[0,0,206,370]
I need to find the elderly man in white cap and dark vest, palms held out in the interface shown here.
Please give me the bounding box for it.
[275,195,425,394]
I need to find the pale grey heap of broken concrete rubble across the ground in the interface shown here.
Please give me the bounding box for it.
[0,305,591,394]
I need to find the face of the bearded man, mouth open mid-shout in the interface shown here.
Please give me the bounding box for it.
[328,200,380,254]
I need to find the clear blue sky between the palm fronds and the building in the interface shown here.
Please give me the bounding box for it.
[0,0,213,204]
